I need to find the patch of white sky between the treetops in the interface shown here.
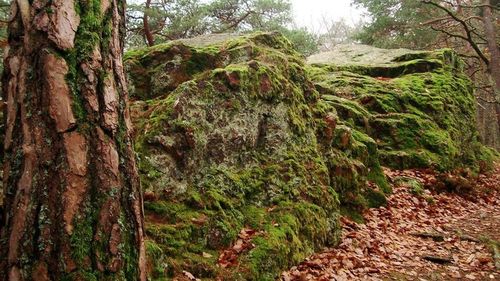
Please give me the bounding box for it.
[290,0,363,31]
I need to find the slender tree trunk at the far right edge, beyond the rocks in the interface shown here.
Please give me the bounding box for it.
[483,0,500,131]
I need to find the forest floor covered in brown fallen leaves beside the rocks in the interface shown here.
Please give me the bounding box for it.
[281,165,500,281]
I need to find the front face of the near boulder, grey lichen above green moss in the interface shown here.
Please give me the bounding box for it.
[128,32,348,280]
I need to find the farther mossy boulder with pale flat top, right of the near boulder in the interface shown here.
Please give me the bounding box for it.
[308,45,492,170]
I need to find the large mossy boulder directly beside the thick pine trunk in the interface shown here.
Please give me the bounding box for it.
[126,33,387,280]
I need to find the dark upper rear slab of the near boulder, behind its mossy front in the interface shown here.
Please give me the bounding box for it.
[124,34,295,100]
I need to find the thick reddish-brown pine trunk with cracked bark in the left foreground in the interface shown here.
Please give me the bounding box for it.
[0,0,146,281]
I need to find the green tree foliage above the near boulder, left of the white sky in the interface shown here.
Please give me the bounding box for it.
[127,0,292,46]
